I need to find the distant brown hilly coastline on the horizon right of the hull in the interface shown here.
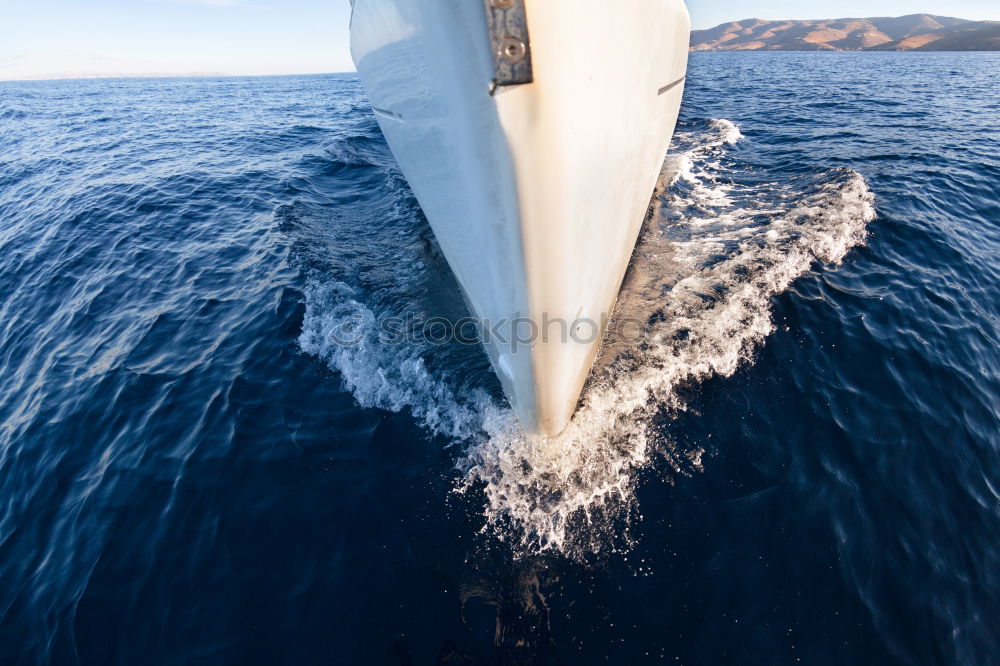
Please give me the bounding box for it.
[691,14,1000,51]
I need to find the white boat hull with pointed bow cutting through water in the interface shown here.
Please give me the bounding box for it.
[351,0,690,435]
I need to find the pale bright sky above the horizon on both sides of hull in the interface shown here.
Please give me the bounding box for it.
[0,0,1000,80]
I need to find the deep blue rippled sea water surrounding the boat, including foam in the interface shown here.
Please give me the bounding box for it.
[0,53,1000,665]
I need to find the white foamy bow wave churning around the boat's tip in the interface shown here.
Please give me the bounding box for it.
[301,120,875,555]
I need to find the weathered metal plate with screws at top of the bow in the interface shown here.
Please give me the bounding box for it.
[484,0,535,89]
